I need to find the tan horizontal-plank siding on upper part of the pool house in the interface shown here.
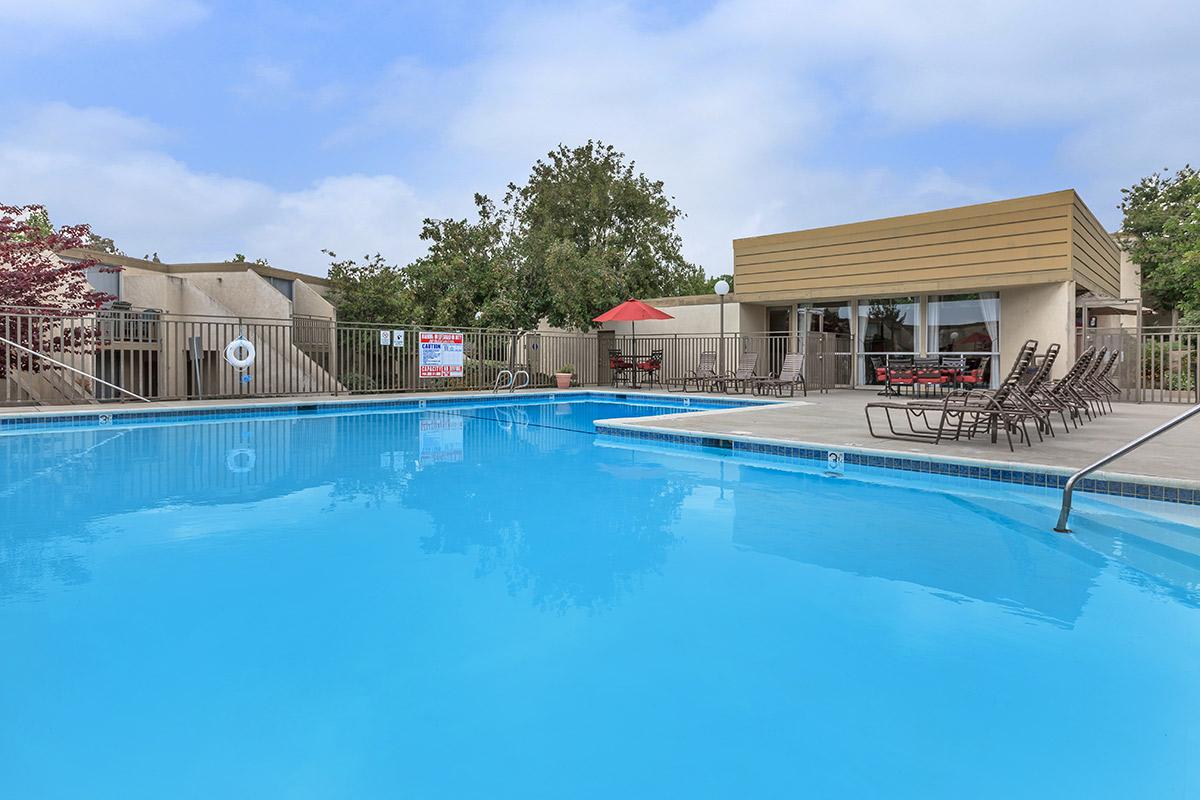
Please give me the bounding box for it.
[733,190,1120,302]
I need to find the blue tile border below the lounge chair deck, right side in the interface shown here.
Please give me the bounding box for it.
[596,420,1200,505]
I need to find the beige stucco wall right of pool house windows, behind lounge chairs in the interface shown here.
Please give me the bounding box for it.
[997,281,1075,378]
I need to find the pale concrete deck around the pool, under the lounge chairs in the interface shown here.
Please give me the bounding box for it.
[0,387,1200,488]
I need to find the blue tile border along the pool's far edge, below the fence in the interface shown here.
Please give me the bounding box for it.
[0,391,778,433]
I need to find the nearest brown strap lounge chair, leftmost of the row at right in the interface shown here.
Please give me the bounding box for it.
[864,339,1042,451]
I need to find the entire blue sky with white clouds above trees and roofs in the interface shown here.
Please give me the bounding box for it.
[0,0,1200,275]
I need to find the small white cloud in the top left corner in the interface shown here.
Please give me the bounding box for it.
[0,0,208,50]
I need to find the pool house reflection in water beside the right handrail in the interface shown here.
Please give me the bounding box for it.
[710,450,1200,626]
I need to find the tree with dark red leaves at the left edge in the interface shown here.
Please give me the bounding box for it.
[0,205,120,377]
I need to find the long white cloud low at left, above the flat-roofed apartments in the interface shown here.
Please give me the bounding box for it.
[0,104,432,275]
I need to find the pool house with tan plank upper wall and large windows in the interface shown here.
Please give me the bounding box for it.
[618,190,1140,386]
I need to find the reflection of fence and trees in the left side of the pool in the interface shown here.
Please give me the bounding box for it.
[0,403,690,608]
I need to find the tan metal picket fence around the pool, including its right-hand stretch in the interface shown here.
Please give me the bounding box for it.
[0,308,1200,405]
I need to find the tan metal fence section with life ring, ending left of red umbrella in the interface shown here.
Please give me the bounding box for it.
[0,309,599,405]
